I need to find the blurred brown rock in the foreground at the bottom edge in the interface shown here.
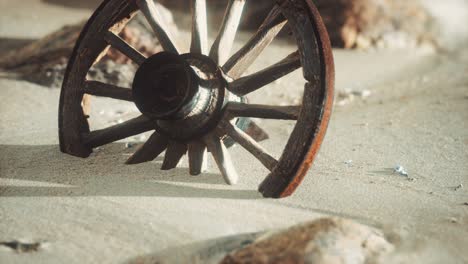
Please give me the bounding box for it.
[221,218,394,264]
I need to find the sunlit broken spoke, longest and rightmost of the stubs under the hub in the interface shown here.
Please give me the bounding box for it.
[204,134,239,185]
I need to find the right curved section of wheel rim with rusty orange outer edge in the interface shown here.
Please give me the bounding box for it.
[259,0,334,198]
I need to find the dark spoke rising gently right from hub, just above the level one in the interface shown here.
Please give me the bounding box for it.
[228,51,301,96]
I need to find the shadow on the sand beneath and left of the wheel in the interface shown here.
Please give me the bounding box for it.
[0,143,261,199]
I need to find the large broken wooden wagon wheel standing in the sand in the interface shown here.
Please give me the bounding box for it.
[59,0,334,198]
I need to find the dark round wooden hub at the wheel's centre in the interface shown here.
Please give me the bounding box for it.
[132,52,227,141]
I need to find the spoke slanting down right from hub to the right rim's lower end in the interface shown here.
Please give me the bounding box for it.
[219,121,278,171]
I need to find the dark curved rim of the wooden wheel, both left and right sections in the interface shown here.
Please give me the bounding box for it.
[59,0,334,198]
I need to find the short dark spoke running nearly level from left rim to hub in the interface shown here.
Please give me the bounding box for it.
[84,81,133,102]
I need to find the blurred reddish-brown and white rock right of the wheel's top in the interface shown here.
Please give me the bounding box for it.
[315,0,432,49]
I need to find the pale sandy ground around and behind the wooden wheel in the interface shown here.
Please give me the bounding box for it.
[0,0,468,263]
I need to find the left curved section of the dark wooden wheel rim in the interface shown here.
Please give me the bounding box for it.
[58,0,136,157]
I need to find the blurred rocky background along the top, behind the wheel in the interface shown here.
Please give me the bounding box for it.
[0,0,468,87]
